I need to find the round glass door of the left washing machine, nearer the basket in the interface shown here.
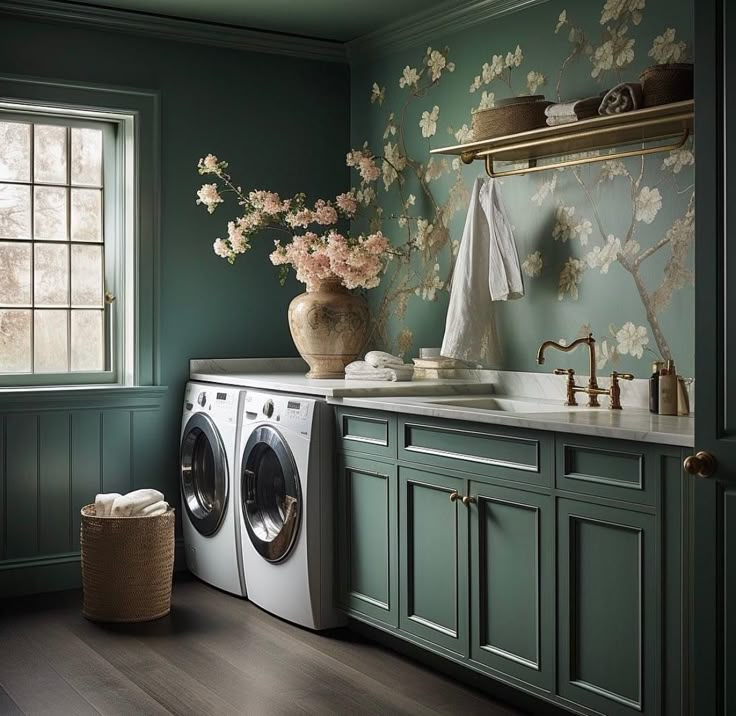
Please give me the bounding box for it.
[179,413,230,537]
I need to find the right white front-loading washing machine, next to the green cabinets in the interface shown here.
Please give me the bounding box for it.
[238,390,345,629]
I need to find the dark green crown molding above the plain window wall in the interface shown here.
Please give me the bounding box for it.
[0,0,347,62]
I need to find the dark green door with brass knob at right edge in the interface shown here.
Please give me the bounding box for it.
[687,0,736,716]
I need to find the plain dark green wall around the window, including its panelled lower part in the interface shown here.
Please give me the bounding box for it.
[0,16,350,594]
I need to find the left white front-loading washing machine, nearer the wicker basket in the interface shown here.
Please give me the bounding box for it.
[179,383,246,597]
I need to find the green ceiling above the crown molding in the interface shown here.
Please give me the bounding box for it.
[66,0,447,42]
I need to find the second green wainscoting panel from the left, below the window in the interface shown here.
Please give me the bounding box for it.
[38,413,73,554]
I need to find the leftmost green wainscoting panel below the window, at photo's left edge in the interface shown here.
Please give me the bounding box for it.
[4,415,38,559]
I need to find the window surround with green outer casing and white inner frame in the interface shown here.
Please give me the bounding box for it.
[0,75,160,391]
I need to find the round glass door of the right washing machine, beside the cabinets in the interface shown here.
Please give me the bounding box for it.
[241,425,302,562]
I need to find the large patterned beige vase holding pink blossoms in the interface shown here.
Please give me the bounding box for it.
[289,279,370,378]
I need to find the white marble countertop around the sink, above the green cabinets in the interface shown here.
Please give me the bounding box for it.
[328,394,695,447]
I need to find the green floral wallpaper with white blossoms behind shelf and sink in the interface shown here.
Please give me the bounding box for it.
[348,0,695,377]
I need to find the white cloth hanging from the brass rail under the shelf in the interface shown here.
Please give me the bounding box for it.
[441,177,524,363]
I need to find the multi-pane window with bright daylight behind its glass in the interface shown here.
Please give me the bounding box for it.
[0,106,126,385]
